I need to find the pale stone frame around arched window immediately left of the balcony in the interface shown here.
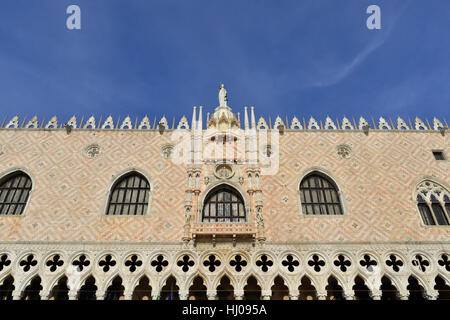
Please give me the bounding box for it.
[99,167,154,219]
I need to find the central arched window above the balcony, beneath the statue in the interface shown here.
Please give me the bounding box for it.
[202,186,246,222]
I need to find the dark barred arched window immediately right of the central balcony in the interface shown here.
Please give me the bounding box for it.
[300,173,343,215]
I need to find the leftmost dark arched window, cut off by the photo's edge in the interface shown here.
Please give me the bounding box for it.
[0,171,31,215]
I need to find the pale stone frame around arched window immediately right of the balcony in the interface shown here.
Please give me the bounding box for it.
[295,167,349,219]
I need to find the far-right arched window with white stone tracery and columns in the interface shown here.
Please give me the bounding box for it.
[416,180,450,226]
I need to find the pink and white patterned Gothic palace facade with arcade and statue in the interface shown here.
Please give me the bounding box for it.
[0,86,450,300]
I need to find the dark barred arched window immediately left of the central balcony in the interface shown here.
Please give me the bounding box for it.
[106,172,150,215]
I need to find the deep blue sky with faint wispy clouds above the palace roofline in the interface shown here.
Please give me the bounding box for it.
[0,0,450,123]
